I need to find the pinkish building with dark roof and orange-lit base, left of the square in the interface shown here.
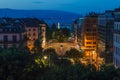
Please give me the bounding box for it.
[22,18,46,50]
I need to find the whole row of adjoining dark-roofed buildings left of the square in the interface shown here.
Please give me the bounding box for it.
[0,18,46,50]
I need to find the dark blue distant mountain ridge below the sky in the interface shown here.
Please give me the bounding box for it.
[0,9,81,24]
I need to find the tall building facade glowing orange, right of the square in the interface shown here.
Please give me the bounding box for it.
[82,16,98,59]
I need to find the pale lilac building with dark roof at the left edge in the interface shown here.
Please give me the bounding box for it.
[0,25,26,48]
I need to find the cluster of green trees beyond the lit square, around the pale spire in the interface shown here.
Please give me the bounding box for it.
[46,24,70,42]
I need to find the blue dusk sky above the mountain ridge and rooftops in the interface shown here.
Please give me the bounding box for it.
[0,0,120,14]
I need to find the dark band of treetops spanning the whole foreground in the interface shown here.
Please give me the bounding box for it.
[0,47,120,80]
